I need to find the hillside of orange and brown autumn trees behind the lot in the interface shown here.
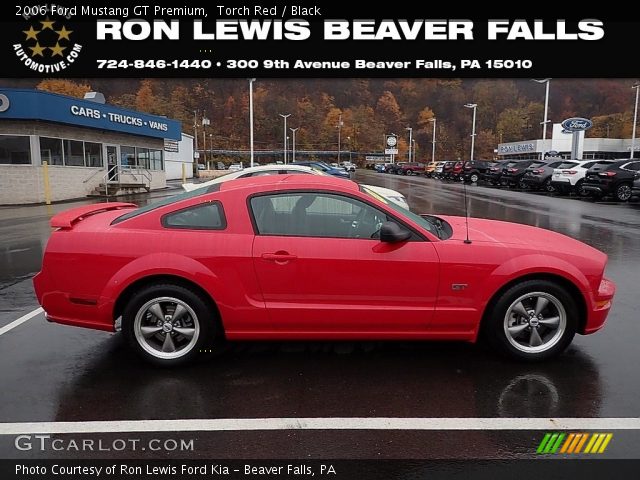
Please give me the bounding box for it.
[0,79,634,159]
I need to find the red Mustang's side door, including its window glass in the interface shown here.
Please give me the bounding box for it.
[249,192,439,337]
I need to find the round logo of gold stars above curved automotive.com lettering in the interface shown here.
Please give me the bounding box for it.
[13,16,82,74]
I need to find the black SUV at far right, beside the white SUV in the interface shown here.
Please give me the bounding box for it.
[583,159,640,202]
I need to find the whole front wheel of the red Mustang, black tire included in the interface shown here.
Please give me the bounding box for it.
[482,280,578,362]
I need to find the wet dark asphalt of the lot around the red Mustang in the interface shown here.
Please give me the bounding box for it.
[0,171,640,458]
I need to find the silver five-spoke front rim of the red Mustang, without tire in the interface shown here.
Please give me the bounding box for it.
[504,292,567,353]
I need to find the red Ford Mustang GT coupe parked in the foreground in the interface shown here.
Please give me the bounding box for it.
[34,175,615,365]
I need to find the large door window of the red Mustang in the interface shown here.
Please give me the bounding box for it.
[251,193,388,239]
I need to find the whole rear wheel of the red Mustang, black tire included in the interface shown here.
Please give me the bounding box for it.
[122,283,218,367]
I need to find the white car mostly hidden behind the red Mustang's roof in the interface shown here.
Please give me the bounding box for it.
[182,164,409,210]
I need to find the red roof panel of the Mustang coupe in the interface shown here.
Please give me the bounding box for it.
[220,174,360,192]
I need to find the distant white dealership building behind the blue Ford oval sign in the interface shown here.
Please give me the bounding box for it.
[496,123,640,160]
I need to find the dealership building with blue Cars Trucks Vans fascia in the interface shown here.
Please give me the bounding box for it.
[0,88,194,205]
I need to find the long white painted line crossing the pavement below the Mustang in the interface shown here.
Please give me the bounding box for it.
[0,417,640,435]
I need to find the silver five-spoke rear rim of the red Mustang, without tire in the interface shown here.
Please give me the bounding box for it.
[133,297,200,359]
